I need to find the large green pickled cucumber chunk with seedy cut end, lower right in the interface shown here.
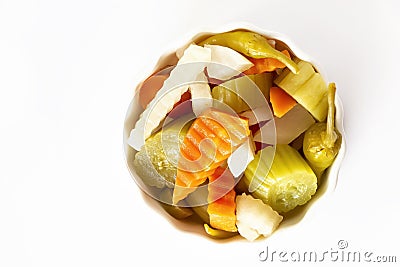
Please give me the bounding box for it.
[242,145,317,213]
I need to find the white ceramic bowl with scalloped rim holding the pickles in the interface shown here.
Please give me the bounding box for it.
[123,23,346,243]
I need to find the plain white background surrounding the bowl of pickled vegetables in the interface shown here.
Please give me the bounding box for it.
[0,0,400,267]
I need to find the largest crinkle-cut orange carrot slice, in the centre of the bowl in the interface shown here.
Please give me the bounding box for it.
[172,108,250,204]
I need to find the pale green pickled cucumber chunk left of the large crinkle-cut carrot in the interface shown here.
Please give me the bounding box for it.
[133,118,190,188]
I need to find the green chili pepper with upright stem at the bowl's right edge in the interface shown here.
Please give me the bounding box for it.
[303,83,342,177]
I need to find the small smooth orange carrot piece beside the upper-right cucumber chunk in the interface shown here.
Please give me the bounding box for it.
[269,87,297,118]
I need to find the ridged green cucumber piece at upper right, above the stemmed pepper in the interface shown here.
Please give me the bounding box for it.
[274,61,328,122]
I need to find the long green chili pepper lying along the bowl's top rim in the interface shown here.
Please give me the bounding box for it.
[199,31,299,73]
